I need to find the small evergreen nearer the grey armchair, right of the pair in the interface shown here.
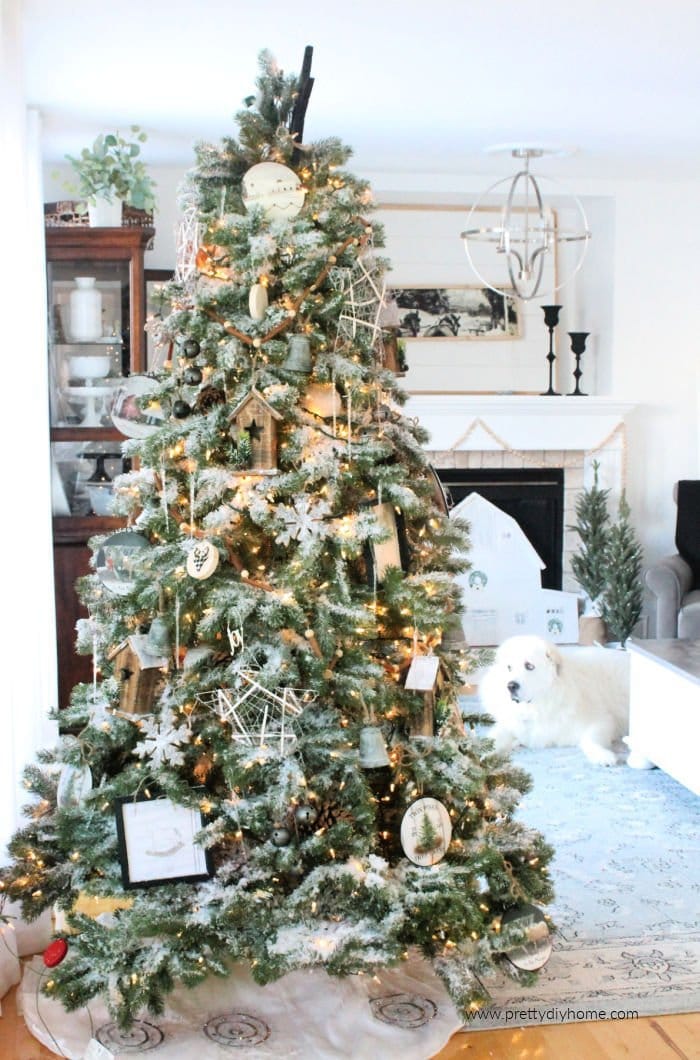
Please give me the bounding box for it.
[602,493,643,644]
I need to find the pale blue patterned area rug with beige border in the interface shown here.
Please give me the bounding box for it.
[462,747,700,1030]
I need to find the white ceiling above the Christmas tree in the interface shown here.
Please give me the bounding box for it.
[21,0,700,177]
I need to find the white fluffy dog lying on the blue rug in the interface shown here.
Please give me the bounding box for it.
[479,636,629,765]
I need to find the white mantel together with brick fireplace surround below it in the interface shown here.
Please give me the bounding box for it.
[404,393,634,591]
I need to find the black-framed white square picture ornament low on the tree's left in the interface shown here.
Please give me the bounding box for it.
[115,795,212,889]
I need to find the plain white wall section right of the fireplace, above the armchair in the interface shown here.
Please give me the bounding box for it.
[611,181,700,559]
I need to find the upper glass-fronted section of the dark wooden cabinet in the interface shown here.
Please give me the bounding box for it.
[47,226,154,523]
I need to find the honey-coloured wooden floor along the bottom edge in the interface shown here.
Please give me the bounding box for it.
[0,990,700,1060]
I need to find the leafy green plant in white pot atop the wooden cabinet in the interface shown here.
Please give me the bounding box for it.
[66,125,156,227]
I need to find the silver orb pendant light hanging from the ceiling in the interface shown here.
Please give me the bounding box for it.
[461,144,591,301]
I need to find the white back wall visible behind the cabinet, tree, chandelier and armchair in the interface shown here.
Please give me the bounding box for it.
[45,160,700,619]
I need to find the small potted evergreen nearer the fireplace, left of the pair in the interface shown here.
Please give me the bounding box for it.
[568,461,610,644]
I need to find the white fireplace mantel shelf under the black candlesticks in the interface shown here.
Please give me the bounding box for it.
[404,392,635,452]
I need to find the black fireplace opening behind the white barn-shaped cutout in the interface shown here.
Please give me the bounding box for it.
[436,467,564,589]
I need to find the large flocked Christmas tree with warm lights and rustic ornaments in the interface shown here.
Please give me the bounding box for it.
[2,47,552,1026]
